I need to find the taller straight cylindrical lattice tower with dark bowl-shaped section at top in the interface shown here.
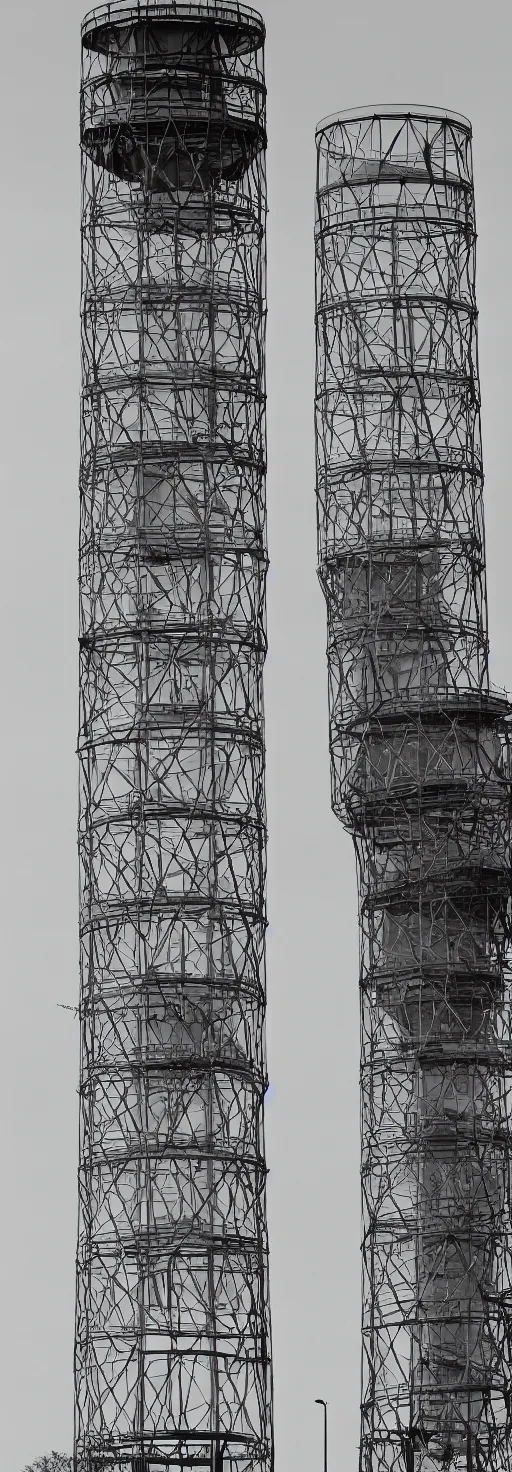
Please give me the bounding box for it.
[77,0,272,1472]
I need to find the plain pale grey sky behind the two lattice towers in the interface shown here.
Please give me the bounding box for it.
[0,0,512,1472]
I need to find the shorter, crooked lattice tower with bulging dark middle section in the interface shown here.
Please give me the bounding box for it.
[316,107,512,1472]
